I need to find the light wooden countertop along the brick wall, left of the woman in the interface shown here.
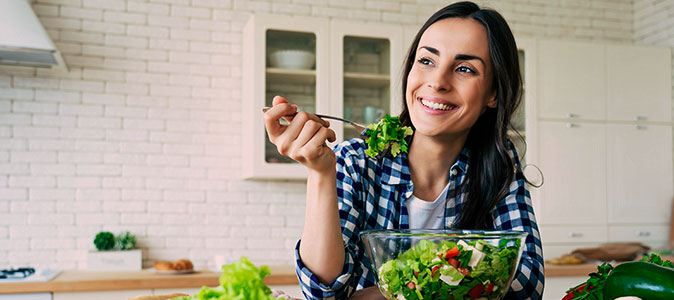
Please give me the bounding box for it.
[0,266,298,294]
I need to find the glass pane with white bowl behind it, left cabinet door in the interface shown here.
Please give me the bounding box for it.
[265,29,316,163]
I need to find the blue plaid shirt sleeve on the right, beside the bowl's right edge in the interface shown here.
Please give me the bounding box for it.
[494,147,545,300]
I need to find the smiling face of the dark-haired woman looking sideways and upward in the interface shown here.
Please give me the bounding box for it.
[405,18,496,136]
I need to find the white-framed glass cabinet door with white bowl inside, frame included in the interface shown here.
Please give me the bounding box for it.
[241,14,331,180]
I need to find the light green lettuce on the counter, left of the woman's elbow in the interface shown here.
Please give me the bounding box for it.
[172,257,283,300]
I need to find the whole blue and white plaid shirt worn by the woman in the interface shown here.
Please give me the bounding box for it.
[295,139,544,299]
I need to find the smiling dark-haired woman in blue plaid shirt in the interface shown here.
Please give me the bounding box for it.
[265,2,544,299]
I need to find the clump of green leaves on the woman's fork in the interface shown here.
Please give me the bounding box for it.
[365,114,413,158]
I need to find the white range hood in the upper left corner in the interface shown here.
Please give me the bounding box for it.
[0,0,65,68]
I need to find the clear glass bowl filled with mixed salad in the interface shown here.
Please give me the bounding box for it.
[360,229,527,300]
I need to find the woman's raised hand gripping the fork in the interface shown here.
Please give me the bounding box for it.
[264,96,336,173]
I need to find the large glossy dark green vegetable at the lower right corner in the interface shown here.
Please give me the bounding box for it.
[602,261,674,300]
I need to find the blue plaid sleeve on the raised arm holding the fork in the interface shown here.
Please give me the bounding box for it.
[295,142,365,300]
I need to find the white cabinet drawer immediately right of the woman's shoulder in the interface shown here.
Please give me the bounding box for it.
[540,225,607,244]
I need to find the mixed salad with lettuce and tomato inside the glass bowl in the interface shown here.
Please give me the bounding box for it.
[379,240,520,300]
